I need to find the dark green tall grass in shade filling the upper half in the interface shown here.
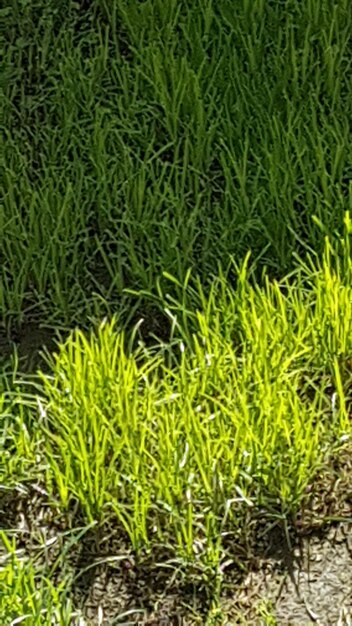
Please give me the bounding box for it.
[0,0,351,325]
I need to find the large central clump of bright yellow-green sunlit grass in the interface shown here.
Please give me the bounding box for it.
[38,239,351,536]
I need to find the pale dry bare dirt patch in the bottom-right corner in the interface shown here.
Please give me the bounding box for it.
[234,523,352,626]
